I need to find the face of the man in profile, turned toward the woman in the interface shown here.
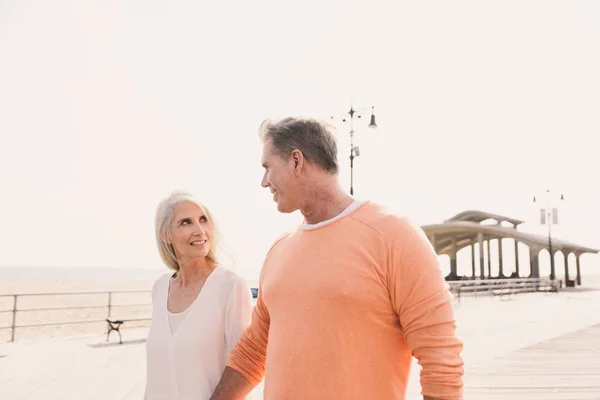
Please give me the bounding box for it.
[261,139,298,213]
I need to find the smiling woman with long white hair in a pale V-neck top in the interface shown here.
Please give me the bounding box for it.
[145,192,252,400]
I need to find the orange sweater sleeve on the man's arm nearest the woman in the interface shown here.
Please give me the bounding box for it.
[227,272,270,386]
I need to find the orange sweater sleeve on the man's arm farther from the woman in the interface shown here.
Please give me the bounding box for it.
[385,219,463,400]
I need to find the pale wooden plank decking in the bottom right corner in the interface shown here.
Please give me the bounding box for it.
[465,324,600,400]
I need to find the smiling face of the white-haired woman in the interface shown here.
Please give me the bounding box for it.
[168,201,212,261]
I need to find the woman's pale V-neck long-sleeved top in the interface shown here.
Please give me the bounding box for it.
[145,267,252,400]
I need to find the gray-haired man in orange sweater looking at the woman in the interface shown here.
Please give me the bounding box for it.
[211,118,463,400]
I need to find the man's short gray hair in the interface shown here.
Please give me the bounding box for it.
[259,117,339,174]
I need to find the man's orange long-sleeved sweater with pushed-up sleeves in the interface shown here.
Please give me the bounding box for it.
[227,202,463,400]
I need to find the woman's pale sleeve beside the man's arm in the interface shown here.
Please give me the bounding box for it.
[225,278,253,356]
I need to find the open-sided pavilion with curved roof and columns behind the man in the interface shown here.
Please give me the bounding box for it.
[422,210,600,286]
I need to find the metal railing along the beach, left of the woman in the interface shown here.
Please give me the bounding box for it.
[0,290,152,342]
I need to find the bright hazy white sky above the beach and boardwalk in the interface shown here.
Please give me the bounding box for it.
[0,0,600,279]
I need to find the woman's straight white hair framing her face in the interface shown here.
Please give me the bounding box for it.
[155,191,219,271]
